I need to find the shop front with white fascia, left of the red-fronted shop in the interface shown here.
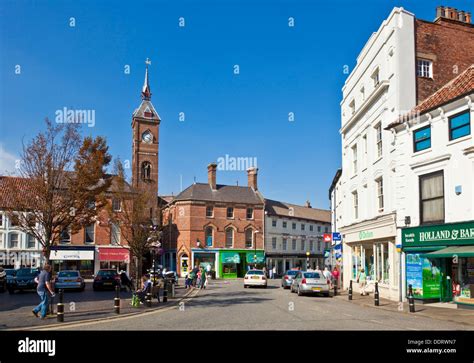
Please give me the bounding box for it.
[49,246,95,278]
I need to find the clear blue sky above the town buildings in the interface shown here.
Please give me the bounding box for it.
[0,0,474,208]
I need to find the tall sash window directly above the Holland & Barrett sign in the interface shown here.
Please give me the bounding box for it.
[420,171,444,224]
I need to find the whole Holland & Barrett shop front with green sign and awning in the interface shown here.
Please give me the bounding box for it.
[402,221,474,308]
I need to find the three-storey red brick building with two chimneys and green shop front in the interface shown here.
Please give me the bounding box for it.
[163,163,264,278]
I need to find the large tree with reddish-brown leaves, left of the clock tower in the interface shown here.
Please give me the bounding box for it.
[2,119,111,262]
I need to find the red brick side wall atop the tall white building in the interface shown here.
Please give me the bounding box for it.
[415,18,474,103]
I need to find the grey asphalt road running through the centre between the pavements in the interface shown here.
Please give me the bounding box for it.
[48,280,474,330]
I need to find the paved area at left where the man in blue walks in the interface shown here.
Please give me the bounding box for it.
[0,282,191,330]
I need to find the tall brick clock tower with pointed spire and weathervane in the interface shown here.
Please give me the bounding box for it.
[132,58,161,216]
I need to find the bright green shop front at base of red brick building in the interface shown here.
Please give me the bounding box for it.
[219,250,265,279]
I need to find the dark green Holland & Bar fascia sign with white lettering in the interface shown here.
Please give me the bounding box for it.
[402,222,474,247]
